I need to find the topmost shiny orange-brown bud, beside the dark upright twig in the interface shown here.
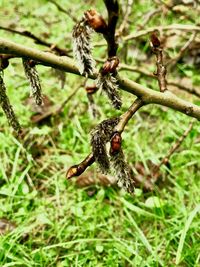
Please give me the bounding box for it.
[85,9,107,33]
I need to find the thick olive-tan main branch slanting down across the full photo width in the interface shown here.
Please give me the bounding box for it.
[0,38,200,120]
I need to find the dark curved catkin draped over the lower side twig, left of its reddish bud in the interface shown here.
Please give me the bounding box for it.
[91,118,119,173]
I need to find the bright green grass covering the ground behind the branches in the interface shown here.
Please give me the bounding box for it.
[0,0,200,267]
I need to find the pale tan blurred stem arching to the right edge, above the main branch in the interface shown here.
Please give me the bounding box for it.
[123,24,200,41]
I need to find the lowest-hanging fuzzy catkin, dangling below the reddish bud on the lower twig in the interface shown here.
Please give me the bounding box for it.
[110,149,134,194]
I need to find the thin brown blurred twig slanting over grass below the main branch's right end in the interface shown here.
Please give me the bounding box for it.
[155,119,195,175]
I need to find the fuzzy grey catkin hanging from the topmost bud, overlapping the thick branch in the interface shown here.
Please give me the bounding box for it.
[72,17,95,76]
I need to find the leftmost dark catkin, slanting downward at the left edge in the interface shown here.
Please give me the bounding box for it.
[0,70,21,134]
